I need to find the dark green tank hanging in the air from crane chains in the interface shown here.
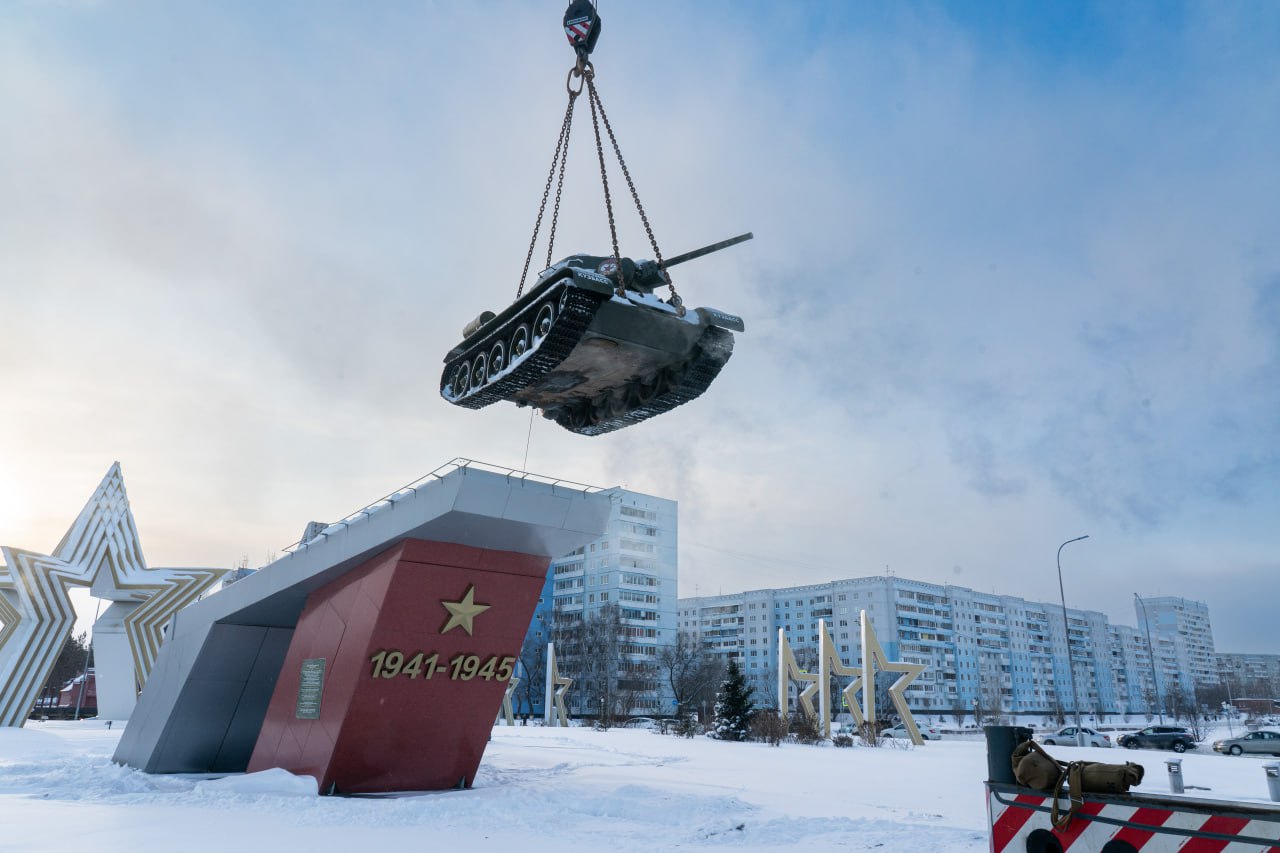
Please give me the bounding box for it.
[440,233,751,435]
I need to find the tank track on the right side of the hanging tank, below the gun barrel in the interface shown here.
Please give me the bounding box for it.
[556,325,733,435]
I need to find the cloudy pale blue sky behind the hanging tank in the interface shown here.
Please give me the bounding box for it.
[0,0,1280,653]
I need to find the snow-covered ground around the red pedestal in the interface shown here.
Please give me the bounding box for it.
[0,720,1274,853]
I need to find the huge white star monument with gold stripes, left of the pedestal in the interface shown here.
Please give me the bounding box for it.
[0,462,228,726]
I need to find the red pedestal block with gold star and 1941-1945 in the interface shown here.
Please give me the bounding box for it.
[248,539,548,793]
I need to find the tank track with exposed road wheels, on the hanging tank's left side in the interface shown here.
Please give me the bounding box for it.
[440,279,608,409]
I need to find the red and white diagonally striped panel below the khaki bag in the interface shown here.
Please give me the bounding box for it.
[987,792,1280,853]
